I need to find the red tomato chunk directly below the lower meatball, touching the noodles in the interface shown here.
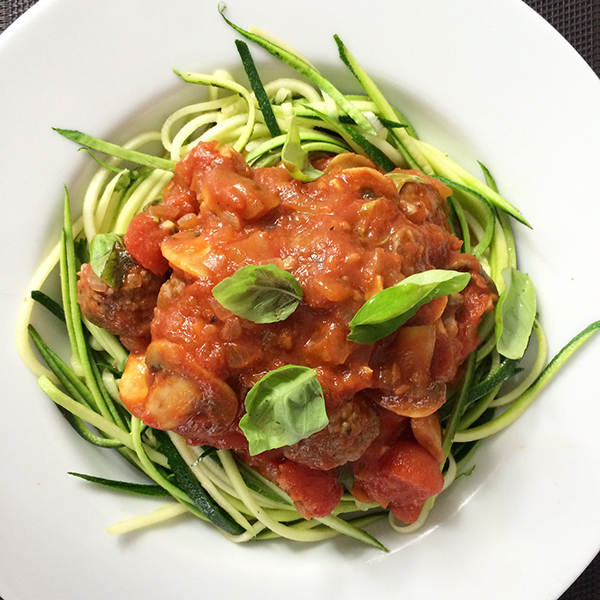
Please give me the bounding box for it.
[277,460,344,519]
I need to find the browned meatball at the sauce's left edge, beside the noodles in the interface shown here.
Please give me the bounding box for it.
[77,263,166,351]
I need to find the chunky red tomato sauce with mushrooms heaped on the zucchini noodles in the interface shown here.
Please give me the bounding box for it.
[94,143,494,522]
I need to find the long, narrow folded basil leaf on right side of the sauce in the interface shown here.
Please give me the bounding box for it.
[348,269,471,344]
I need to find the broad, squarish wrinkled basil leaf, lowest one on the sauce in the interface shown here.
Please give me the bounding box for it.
[240,365,329,456]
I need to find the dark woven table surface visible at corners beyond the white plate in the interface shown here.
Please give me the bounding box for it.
[0,0,600,600]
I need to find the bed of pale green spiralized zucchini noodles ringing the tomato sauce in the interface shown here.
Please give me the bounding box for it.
[17,17,600,550]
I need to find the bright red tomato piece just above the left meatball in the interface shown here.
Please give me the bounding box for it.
[124,212,169,275]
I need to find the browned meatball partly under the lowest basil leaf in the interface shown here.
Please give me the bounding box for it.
[283,395,379,471]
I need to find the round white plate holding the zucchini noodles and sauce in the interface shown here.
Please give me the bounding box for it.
[0,0,600,600]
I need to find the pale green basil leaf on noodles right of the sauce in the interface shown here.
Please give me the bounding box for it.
[495,267,536,359]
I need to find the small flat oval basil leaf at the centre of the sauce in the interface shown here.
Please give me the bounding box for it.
[213,265,302,323]
